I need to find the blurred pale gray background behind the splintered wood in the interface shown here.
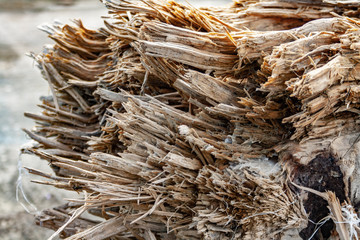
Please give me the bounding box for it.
[0,0,231,240]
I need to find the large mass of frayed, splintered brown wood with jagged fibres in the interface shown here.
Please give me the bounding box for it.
[23,0,360,240]
